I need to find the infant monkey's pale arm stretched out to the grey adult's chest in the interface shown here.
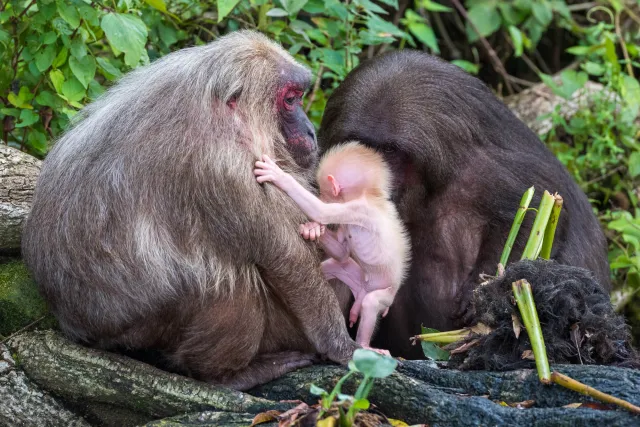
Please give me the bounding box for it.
[254,155,371,228]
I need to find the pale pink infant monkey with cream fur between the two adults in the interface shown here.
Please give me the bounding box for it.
[254,142,411,354]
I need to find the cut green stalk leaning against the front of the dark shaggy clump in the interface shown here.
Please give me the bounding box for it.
[511,279,551,384]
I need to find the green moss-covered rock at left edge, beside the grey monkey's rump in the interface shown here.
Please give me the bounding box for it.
[0,261,56,337]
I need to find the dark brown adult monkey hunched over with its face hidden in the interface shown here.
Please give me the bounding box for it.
[318,50,610,358]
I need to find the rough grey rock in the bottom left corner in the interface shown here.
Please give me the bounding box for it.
[0,344,89,427]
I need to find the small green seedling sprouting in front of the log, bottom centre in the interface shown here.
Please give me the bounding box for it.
[310,349,398,427]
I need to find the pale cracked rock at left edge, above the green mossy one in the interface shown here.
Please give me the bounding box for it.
[0,145,42,253]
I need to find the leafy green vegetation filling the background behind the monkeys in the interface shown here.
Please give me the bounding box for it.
[0,0,640,344]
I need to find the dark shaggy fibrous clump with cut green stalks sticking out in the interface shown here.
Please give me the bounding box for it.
[449,260,640,370]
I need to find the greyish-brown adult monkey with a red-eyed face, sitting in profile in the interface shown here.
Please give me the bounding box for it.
[23,32,358,390]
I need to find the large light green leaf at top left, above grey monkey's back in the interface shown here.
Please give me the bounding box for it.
[101,13,148,67]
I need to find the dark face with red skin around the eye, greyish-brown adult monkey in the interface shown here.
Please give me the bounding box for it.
[276,77,318,169]
